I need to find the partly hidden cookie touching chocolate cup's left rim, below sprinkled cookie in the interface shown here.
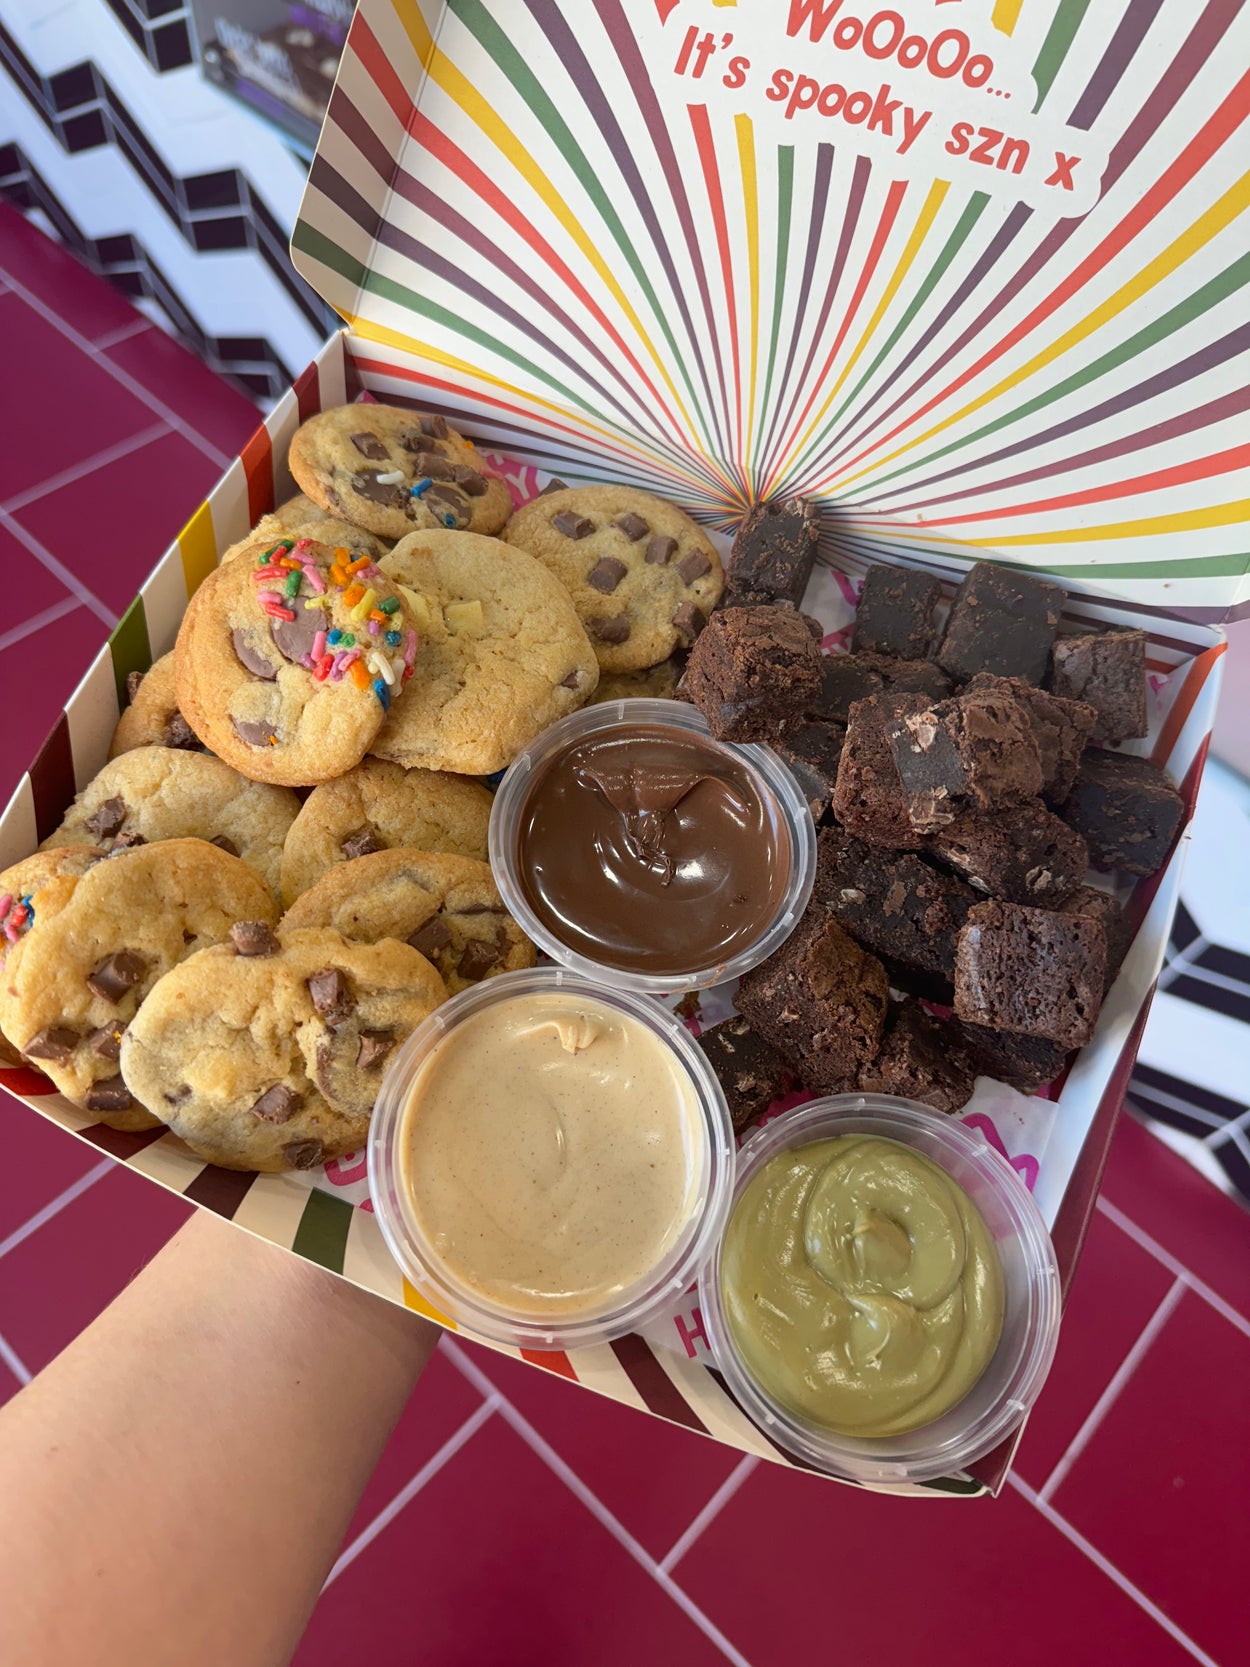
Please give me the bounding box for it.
[282,758,492,909]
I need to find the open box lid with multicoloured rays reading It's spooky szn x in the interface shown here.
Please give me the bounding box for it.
[292,0,1250,620]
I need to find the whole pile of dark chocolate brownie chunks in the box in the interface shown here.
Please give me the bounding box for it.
[680,498,1183,1129]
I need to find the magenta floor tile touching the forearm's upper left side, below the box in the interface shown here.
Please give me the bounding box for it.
[0,1166,193,1372]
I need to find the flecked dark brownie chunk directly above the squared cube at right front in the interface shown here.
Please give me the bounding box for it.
[928,798,1090,909]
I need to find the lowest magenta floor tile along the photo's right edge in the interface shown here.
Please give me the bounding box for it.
[1052,1294,1250,1662]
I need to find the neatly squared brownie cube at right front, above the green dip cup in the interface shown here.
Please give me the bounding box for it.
[955,904,1107,1049]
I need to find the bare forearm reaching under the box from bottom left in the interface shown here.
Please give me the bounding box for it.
[0,1214,437,1667]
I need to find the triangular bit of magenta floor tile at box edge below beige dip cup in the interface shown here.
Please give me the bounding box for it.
[465,1345,742,1560]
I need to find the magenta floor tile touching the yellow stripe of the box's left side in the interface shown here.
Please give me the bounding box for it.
[12,430,220,615]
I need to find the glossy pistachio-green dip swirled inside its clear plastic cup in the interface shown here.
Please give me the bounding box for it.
[720,1135,1003,1437]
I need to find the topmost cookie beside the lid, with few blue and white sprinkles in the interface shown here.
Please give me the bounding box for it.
[290,403,512,538]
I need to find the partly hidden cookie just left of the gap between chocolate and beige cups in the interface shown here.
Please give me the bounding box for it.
[282,850,538,995]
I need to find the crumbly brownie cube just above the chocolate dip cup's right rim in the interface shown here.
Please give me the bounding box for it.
[683,608,820,742]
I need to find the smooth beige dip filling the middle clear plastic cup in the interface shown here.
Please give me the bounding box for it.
[400,992,708,1315]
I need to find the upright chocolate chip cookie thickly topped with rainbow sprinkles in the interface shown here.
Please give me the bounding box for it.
[175,538,417,787]
